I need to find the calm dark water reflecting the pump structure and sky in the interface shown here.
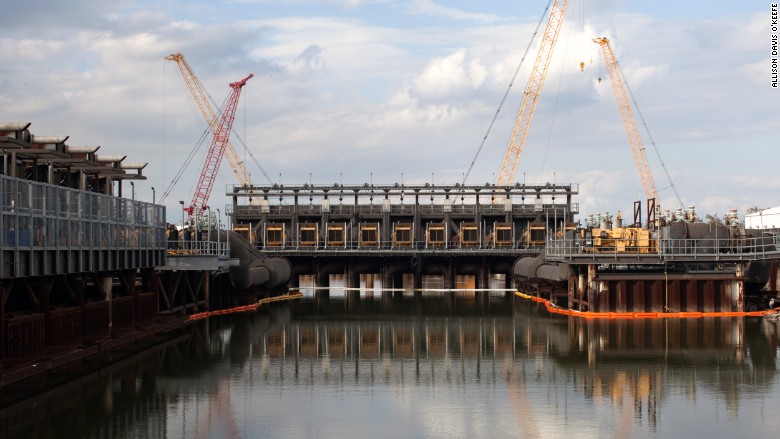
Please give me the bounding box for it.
[0,291,780,438]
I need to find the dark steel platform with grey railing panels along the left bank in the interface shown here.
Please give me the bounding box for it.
[0,123,235,392]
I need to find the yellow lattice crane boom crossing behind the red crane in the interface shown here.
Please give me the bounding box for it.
[165,53,260,204]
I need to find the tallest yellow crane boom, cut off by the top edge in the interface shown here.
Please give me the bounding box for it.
[496,0,569,186]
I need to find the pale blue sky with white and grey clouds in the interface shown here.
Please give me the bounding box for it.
[0,0,780,221]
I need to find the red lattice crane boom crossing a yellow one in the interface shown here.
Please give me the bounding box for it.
[184,73,255,218]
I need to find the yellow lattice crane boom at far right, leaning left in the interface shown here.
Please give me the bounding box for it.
[593,37,658,200]
